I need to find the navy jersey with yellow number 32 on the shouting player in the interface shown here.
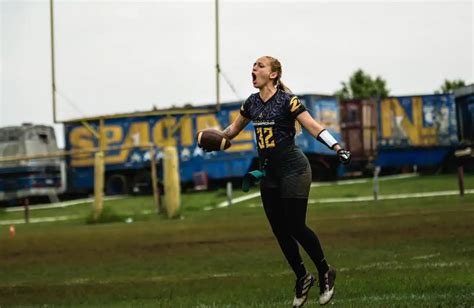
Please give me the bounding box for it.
[240,90,306,156]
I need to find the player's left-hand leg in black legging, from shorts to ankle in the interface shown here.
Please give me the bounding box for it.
[260,187,306,279]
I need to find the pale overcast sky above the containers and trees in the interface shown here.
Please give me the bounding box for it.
[0,0,474,145]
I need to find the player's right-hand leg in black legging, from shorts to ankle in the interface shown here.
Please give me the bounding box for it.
[282,198,329,275]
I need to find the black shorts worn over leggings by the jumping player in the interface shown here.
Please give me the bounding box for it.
[260,146,312,199]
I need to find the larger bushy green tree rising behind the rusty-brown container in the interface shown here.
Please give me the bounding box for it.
[335,69,389,99]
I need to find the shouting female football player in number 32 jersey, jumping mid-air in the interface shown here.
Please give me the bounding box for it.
[223,56,351,307]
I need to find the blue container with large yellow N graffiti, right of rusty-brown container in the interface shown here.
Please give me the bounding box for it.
[374,94,459,167]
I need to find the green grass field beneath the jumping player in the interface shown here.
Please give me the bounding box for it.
[0,175,474,308]
